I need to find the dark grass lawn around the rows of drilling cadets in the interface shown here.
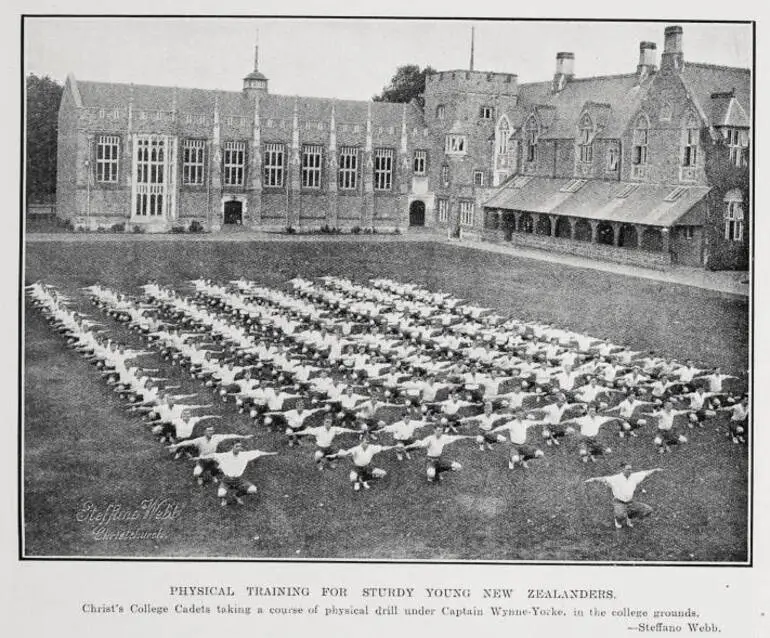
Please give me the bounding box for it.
[24,239,748,561]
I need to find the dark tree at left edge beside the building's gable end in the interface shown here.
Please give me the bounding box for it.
[26,74,64,202]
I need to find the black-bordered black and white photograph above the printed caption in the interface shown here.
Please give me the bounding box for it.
[18,15,755,564]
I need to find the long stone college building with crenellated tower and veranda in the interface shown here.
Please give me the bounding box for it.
[57,27,751,268]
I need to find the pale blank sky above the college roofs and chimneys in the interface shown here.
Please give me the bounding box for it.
[24,17,752,100]
